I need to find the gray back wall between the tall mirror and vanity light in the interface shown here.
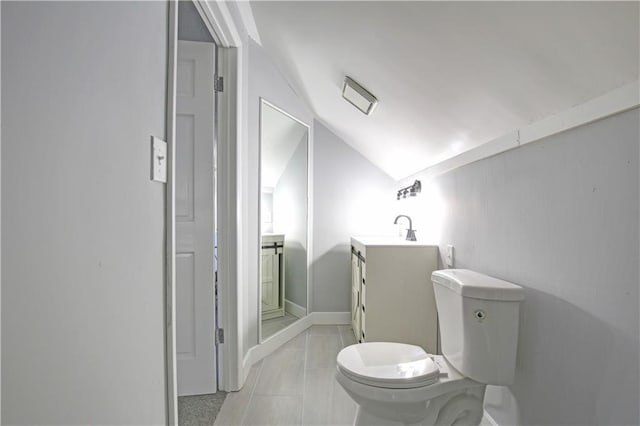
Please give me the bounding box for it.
[311,121,397,312]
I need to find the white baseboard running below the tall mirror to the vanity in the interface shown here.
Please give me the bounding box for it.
[241,312,351,386]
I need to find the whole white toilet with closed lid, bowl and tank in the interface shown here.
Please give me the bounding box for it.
[336,269,524,425]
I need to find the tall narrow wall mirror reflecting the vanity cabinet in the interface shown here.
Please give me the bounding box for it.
[258,99,309,341]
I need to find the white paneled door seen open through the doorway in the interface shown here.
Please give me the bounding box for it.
[175,41,217,395]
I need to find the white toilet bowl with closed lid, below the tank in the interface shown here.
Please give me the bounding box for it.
[336,342,486,425]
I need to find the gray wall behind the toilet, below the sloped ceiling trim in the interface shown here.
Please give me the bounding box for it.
[410,109,640,425]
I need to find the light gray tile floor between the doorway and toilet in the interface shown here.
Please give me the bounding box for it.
[214,325,356,426]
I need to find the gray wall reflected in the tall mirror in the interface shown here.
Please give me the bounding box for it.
[273,133,309,308]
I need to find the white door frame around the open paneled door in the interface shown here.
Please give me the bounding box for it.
[165,0,243,425]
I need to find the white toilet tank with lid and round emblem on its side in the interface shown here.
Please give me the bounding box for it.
[431,269,524,385]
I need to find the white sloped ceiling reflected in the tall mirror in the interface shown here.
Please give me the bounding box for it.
[260,104,307,188]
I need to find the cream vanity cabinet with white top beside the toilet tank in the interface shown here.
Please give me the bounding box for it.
[351,237,438,354]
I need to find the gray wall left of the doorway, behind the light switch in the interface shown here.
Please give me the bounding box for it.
[2,2,168,424]
